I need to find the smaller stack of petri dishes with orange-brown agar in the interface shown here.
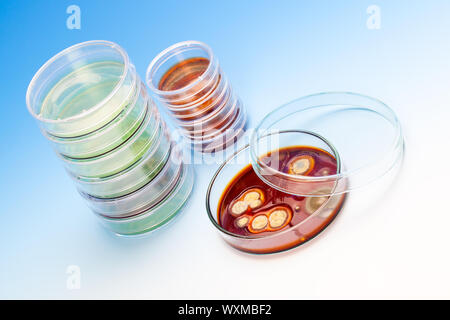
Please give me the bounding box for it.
[146,41,246,152]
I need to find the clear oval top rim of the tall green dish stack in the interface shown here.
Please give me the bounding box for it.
[26,40,130,123]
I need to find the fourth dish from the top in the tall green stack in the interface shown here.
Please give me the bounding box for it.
[72,126,172,199]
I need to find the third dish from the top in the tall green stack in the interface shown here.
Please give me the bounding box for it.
[60,100,164,178]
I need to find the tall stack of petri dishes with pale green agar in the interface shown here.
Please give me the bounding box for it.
[27,41,193,235]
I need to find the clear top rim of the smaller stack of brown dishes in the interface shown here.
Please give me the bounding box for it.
[145,40,219,96]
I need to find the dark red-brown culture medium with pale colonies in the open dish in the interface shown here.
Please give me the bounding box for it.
[218,146,344,253]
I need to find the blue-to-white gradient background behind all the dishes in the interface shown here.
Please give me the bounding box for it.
[0,0,450,299]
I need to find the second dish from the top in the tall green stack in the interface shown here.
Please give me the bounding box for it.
[42,81,149,159]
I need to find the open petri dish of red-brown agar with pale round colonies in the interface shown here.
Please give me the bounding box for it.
[207,131,345,253]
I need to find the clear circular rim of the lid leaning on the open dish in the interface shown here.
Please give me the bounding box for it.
[250,92,403,186]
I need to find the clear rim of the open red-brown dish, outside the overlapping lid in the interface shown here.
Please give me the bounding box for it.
[206,140,339,241]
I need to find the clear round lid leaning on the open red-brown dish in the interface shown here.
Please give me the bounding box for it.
[250,92,404,197]
